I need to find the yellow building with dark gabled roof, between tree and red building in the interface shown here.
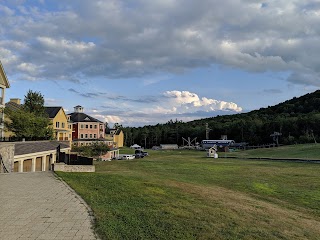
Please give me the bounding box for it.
[45,107,72,144]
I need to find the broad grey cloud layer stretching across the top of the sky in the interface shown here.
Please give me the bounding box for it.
[0,0,320,85]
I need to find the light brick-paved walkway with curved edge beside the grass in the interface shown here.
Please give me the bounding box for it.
[0,172,97,240]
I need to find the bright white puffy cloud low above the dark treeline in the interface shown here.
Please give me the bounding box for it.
[92,90,242,126]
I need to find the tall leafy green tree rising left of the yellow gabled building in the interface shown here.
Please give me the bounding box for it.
[23,90,45,116]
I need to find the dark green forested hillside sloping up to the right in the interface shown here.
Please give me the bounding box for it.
[123,90,320,148]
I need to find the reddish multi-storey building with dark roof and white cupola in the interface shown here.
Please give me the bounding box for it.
[68,105,107,147]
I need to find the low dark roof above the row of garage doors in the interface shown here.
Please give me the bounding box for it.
[14,141,70,156]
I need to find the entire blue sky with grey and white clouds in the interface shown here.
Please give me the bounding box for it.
[0,0,320,127]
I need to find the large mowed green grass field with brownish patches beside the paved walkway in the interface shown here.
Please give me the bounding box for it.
[58,146,320,240]
